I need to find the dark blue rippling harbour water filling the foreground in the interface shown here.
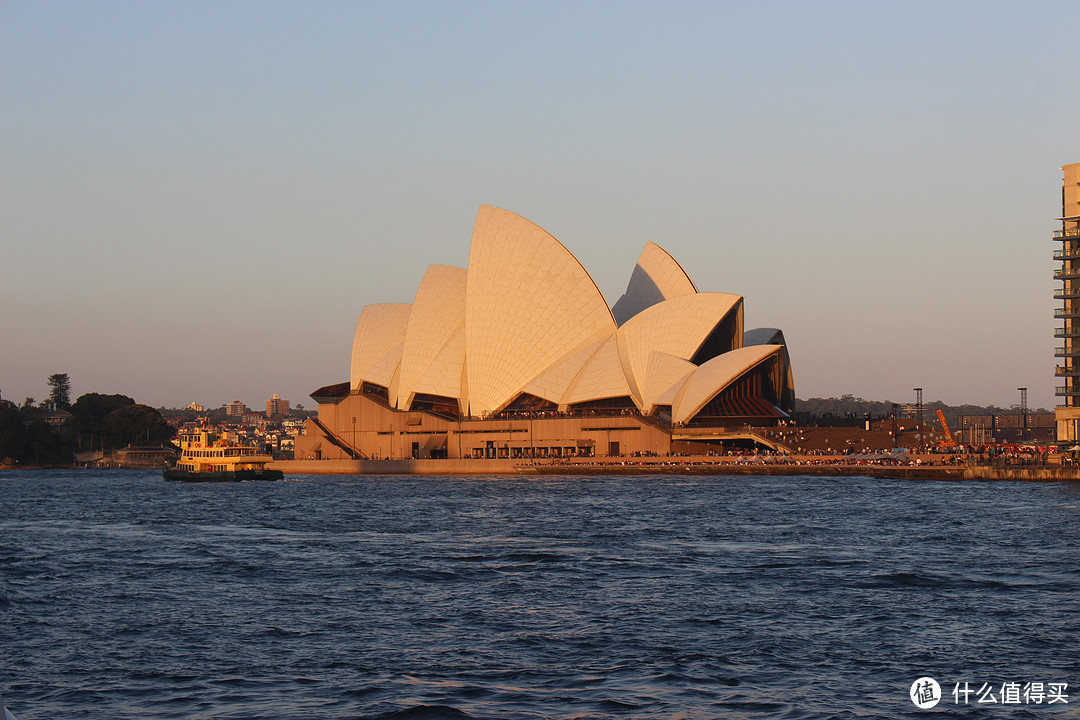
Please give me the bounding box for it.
[0,472,1080,720]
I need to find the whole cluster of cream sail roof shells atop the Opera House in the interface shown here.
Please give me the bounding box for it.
[341,206,793,422]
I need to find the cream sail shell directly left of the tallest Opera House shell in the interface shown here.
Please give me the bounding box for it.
[391,264,468,410]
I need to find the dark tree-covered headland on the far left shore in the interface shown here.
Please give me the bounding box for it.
[0,373,176,465]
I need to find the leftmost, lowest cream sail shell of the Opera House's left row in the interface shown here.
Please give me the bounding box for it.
[349,302,413,390]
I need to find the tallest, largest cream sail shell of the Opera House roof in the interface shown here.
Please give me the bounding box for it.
[464,205,616,416]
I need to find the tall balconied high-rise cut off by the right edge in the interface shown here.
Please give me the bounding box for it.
[1054,163,1080,444]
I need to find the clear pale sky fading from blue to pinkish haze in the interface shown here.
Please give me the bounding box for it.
[0,0,1080,408]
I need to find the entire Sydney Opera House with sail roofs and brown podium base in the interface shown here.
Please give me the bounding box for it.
[296,206,795,460]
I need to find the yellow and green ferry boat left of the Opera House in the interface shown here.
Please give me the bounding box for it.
[161,427,285,483]
